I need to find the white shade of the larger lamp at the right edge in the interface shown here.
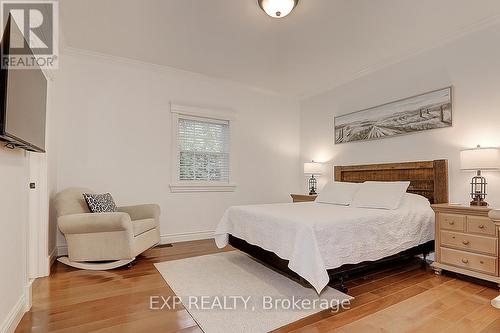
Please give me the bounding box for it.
[460,147,500,171]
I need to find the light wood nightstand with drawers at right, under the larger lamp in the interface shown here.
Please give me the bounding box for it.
[432,204,500,286]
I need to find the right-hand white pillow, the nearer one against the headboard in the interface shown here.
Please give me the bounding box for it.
[352,182,410,210]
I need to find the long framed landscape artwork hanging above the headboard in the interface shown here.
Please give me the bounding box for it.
[334,87,452,144]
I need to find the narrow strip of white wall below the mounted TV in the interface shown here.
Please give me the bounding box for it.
[0,147,29,332]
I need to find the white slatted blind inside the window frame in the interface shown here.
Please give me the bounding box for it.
[177,116,229,182]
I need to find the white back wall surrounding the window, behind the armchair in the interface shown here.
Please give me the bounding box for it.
[54,50,300,245]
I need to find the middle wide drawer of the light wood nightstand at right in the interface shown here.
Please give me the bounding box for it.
[441,231,498,256]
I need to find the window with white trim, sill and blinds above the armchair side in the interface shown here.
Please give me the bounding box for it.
[170,105,235,192]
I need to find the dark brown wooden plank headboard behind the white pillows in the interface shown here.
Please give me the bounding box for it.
[335,160,448,204]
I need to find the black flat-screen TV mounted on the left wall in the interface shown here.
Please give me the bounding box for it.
[0,17,47,152]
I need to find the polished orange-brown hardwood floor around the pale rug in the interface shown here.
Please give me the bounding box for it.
[16,241,500,333]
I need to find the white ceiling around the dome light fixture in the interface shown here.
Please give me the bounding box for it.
[60,0,500,97]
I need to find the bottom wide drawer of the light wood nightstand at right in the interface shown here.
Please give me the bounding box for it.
[441,248,498,276]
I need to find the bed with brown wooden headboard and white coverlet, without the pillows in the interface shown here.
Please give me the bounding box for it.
[215,160,448,293]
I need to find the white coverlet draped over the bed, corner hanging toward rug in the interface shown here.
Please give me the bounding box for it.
[215,194,434,294]
